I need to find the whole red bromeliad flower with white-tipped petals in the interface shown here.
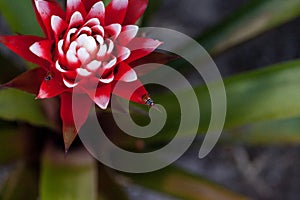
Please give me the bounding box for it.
[0,0,161,149]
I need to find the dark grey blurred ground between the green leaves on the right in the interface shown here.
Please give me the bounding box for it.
[128,0,300,200]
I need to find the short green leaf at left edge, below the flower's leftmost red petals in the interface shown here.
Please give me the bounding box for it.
[0,89,52,127]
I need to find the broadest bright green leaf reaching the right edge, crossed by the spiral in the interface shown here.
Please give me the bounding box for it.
[133,60,300,142]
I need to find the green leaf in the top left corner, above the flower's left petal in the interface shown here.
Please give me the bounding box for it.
[0,0,43,36]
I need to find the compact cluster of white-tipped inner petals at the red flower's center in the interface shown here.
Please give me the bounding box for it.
[56,18,120,87]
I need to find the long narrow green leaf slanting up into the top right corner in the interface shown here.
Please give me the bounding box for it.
[197,0,300,54]
